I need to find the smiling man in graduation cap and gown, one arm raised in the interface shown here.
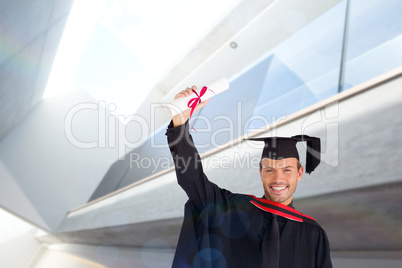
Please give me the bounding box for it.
[166,87,332,268]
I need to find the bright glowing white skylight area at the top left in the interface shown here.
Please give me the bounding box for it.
[45,0,243,115]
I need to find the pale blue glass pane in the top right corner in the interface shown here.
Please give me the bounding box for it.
[342,0,402,90]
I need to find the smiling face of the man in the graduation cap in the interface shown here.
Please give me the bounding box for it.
[260,158,303,205]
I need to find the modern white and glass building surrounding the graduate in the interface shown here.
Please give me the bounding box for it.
[0,0,402,268]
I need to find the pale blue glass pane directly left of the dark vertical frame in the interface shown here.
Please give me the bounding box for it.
[252,1,346,128]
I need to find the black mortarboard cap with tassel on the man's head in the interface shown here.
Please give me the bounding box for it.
[247,135,321,174]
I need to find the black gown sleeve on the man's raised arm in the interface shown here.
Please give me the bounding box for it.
[166,121,231,209]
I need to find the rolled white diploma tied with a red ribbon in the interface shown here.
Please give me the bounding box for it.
[164,77,229,116]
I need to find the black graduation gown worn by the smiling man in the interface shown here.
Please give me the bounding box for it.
[166,122,332,268]
